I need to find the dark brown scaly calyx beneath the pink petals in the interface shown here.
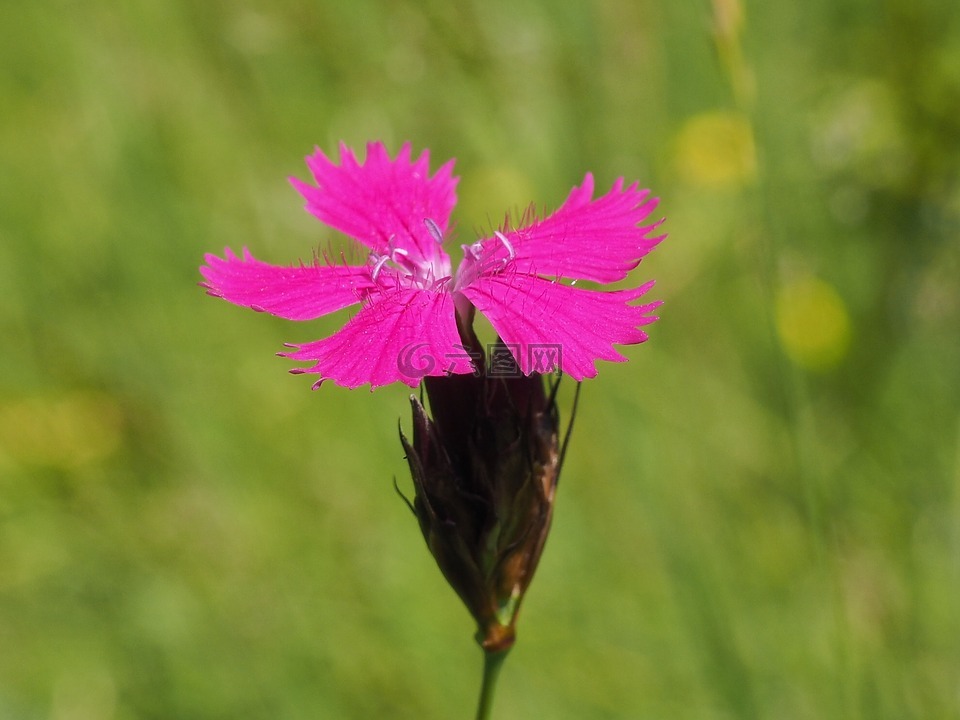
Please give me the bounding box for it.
[400,346,562,652]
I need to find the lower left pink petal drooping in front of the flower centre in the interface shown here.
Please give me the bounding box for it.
[281,289,473,390]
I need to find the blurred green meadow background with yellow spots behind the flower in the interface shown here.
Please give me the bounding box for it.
[0,0,960,720]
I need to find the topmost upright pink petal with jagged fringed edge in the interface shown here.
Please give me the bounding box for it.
[290,142,458,260]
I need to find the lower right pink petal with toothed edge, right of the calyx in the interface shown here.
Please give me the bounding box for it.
[461,272,660,381]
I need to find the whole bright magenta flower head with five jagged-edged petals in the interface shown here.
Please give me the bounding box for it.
[200,143,664,388]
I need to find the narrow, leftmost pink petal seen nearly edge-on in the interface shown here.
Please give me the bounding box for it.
[200,248,375,320]
